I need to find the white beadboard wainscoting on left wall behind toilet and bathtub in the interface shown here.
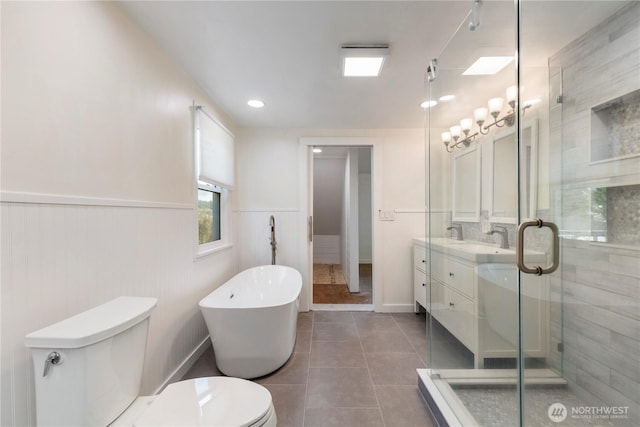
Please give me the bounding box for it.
[0,197,239,426]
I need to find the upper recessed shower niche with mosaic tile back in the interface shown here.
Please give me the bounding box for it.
[591,89,640,162]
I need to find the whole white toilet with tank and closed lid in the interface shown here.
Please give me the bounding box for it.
[25,297,277,427]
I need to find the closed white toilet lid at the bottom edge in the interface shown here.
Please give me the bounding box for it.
[135,377,271,427]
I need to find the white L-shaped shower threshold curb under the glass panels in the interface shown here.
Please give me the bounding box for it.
[416,369,567,427]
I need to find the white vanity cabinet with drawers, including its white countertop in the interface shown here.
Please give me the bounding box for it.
[413,238,549,368]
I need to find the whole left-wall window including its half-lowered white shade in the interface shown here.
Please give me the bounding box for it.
[194,107,234,256]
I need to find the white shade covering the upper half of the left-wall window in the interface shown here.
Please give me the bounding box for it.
[196,108,234,190]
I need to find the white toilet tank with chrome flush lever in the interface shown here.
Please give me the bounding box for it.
[25,297,157,426]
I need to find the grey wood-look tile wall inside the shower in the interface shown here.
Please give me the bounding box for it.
[549,2,640,420]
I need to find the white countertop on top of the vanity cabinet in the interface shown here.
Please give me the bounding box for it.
[415,237,546,264]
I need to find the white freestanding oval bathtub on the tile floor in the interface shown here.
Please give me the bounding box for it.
[200,265,302,378]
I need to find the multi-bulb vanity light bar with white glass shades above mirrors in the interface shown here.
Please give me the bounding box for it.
[440,86,540,153]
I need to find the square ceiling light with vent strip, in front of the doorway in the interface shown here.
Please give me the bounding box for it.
[340,44,389,77]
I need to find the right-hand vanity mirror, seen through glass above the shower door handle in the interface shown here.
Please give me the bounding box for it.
[489,120,538,224]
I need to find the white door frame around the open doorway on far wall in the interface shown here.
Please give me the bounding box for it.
[298,137,383,312]
